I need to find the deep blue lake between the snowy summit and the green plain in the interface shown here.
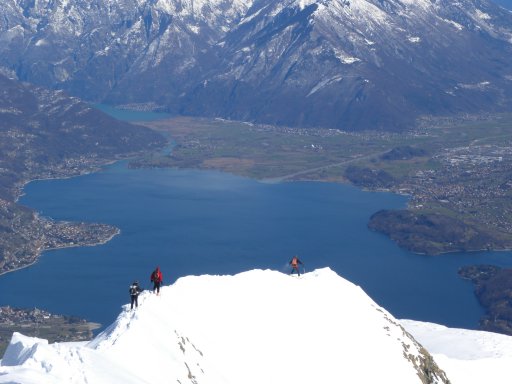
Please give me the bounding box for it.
[0,109,512,328]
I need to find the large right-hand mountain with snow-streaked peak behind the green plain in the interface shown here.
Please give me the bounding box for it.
[188,0,512,130]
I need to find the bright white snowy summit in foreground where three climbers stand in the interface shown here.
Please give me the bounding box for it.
[0,269,448,384]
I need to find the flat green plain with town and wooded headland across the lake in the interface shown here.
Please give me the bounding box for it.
[135,115,512,255]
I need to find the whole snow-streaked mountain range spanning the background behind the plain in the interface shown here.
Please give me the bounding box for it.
[0,0,512,130]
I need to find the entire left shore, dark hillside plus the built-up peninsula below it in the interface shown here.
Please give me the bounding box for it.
[0,75,165,273]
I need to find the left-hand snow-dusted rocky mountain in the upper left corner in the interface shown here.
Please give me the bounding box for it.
[0,0,254,104]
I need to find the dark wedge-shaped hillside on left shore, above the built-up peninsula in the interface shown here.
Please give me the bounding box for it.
[0,75,164,200]
